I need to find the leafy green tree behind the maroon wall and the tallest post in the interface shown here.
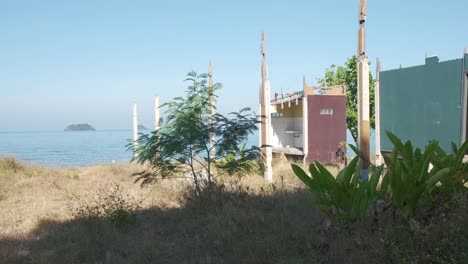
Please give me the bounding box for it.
[317,56,375,142]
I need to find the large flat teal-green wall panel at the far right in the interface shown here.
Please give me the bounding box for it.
[380,59,463,151]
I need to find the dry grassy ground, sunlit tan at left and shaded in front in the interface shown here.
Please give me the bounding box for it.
[0,158,468,263]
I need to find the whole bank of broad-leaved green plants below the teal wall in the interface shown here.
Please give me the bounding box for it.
[292,131,468,221]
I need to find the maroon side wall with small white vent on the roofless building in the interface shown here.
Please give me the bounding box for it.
[307,95,346,163]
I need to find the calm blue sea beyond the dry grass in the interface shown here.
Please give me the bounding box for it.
[0,130,375,168]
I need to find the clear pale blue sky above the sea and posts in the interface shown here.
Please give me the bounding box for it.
[0,0,468,131]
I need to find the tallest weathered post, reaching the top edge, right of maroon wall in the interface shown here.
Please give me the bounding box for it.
[357,0,370,180]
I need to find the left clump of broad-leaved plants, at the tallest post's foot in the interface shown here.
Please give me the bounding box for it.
[292,157,385,218]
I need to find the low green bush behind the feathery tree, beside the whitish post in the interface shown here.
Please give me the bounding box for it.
[215,144,260,175]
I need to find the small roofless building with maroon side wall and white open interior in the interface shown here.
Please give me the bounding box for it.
[269,78,346,164]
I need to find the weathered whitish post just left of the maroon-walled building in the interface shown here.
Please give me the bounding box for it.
[260,33,273,182]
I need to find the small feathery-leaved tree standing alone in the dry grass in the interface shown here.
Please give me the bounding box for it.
[130,71,259,195]
